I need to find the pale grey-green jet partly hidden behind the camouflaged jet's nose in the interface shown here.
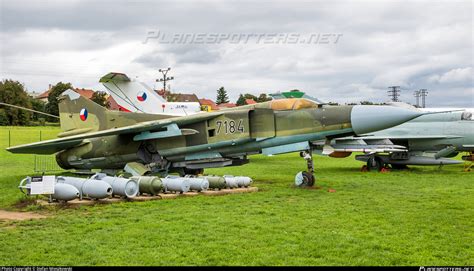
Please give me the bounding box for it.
[313,104,474,171]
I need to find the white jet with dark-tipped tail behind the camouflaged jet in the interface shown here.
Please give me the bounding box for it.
[99,72,201,116]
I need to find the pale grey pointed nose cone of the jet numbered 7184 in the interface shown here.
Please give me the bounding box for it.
[351,105,423,135]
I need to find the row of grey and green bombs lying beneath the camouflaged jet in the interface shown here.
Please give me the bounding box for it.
[19,173,253,201]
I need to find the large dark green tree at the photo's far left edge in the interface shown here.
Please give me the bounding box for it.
[0,79,31,125]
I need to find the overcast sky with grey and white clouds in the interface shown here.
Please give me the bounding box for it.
[0,0,474,107]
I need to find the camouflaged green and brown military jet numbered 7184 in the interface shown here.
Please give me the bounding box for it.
[7,90,423,186]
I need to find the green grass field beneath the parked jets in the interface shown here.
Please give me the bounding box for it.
[0,128,474,265]
